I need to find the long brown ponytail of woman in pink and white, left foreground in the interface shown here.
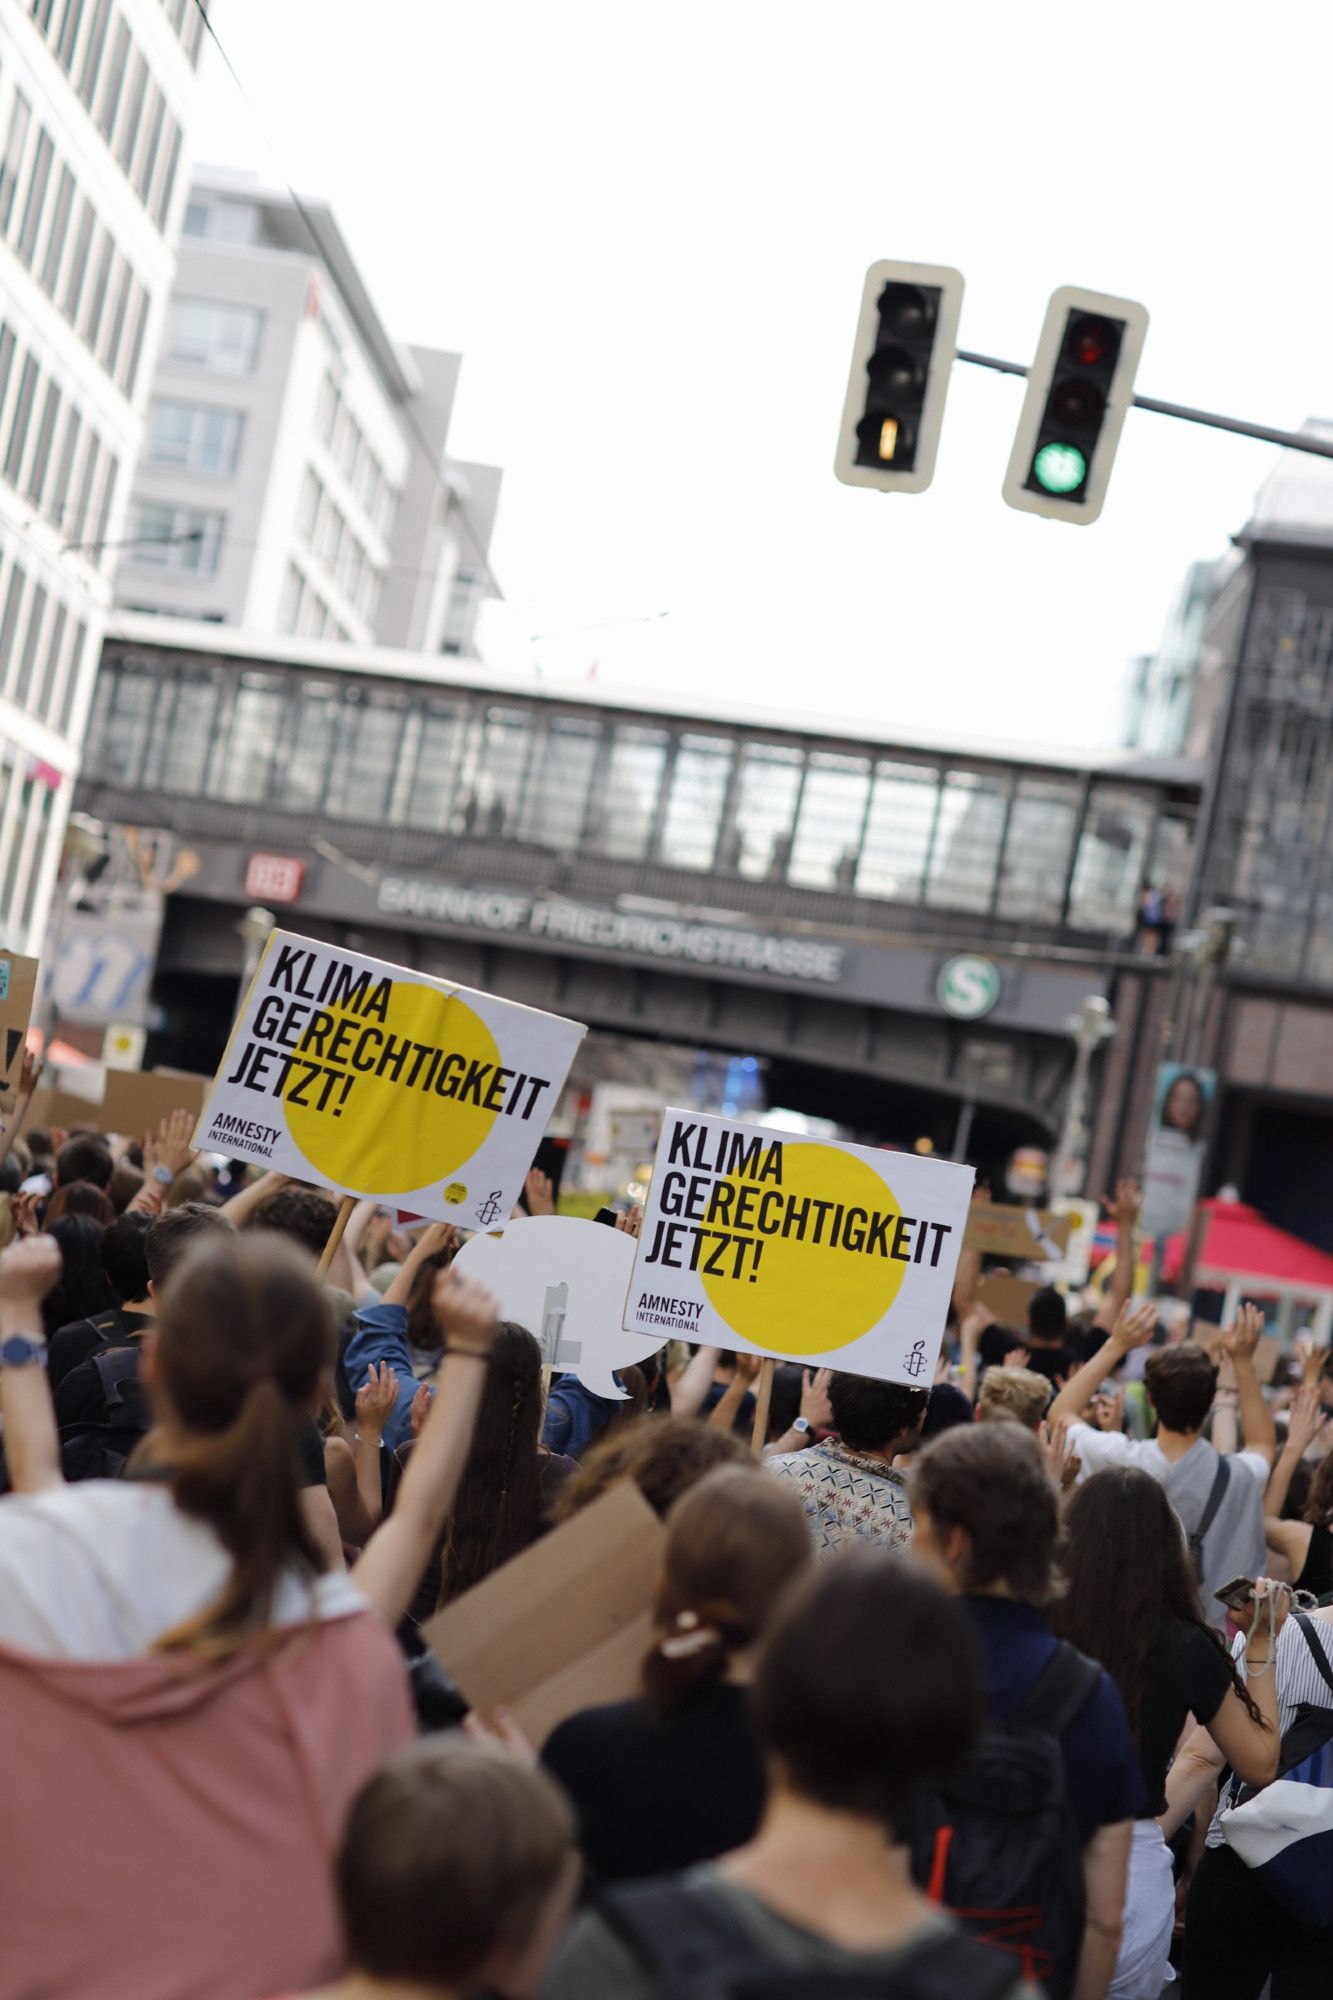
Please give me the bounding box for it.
[154,1232,334,1658]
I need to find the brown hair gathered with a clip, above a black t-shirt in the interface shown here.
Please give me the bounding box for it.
[642,1466,813,1708]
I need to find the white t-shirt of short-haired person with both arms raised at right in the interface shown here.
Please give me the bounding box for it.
[1069,1424,1269,1632]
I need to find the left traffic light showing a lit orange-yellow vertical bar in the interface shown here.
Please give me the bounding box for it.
[833,262,963,494]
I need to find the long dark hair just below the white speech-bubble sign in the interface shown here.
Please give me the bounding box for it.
[440,1320,544,1604]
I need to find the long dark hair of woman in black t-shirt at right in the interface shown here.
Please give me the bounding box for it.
[1051,1466,1263,1742]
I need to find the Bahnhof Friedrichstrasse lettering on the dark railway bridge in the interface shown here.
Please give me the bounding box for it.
[376,876,845,986]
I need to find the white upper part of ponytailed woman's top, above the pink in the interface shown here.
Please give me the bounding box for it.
[0,1480,366,1660]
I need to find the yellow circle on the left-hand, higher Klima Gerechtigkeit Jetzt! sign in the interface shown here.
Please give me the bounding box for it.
[282,982,500,1194]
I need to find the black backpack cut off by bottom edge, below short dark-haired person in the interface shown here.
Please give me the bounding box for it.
[594,1878,1019,2000]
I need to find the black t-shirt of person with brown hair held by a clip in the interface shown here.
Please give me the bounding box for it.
[542,1684,765,1882]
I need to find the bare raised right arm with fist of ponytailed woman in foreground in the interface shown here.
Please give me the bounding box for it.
[352,1270,498,1626]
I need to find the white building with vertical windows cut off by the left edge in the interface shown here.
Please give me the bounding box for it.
[0,0,204,952]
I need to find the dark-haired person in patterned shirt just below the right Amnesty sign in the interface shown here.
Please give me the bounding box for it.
[767,1374,929,1558]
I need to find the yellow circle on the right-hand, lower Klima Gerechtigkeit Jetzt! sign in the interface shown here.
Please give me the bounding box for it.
[699,1144,907,1354]
